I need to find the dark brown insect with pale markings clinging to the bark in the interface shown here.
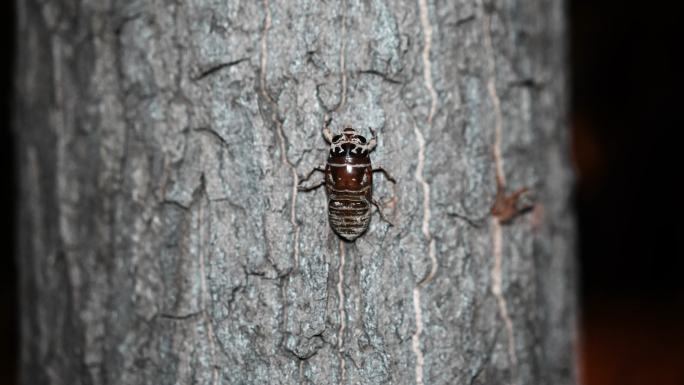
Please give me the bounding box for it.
[299,120,396,241]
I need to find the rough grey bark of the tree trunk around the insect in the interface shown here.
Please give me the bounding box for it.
[15,0,575,385]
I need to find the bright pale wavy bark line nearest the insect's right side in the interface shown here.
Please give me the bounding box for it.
[411,0,437,385]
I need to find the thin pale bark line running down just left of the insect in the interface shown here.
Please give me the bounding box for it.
[259,0,299,270]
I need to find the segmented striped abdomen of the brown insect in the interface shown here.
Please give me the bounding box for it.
[328,187,371,241]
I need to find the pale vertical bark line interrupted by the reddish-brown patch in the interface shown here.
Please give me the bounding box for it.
[481,3,518,384]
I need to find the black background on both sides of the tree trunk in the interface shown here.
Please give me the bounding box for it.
[0,0,684,385]
